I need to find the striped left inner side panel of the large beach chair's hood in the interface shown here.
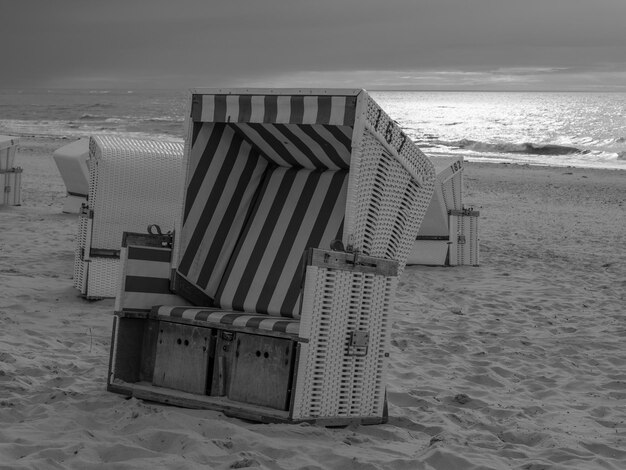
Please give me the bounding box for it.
[178,124,268,298]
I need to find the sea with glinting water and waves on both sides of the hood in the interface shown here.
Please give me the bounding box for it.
[0,89,626,169]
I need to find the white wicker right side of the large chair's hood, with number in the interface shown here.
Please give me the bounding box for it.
[344,94,435,271]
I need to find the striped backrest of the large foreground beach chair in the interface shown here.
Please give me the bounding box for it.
[215,167,348,318]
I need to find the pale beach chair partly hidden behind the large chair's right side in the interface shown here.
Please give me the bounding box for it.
[407,156,480,266]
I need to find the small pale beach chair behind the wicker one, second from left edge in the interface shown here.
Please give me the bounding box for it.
[52,139,89,214]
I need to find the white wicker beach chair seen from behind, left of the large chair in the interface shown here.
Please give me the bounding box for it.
[74,135,183,299]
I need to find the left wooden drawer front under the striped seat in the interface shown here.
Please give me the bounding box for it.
[152,322,215,395]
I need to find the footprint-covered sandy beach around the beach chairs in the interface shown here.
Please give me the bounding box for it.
[0,138,626,470]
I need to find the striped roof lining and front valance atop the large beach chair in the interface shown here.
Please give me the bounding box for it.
[191,94,356,170]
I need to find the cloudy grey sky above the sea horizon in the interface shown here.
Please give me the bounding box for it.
[0,0,626,91]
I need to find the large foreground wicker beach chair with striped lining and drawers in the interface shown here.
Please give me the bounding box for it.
[107,89,435,425]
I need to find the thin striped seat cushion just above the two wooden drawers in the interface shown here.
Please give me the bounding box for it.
[153,306,300,339]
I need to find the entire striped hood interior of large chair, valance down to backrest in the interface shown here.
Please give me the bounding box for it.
[177,92,356,317]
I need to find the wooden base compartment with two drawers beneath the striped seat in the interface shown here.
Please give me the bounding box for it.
[110,311,299,411]
